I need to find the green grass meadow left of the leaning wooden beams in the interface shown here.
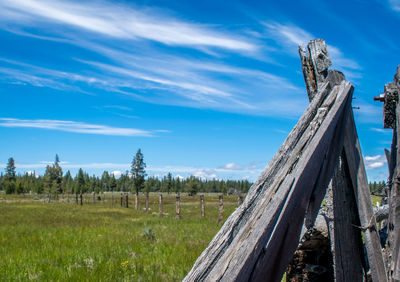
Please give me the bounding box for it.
[0,195,237,281]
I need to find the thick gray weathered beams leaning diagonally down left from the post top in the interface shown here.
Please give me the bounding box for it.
[185,79,352,281]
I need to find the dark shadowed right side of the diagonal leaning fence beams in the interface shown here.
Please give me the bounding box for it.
[251,82,353,281]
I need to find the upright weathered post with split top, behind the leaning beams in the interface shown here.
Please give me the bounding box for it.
[299,39,370,281]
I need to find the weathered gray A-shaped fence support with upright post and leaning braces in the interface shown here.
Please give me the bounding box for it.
[184,39,388,281]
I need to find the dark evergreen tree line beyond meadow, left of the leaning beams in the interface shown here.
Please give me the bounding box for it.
[0,152,252,196]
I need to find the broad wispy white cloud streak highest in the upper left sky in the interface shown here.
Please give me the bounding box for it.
[0,0,257,51]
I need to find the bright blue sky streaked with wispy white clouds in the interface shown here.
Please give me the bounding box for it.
[0,0,400,181]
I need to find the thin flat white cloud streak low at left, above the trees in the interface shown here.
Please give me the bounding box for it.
[0,118,163,137]
